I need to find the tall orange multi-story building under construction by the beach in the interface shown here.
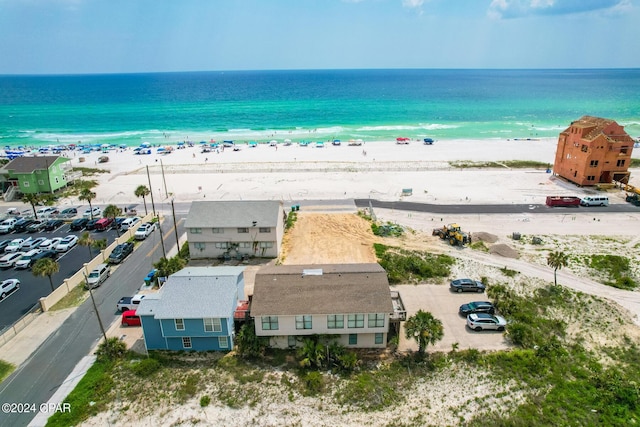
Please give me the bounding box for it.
[553,116,633,186]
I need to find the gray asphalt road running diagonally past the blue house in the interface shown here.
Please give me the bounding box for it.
[0,221,175,427]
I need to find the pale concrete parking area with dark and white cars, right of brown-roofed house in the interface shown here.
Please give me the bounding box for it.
[393,283,509,352]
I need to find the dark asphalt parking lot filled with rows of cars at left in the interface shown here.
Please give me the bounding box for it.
[0,213,117,330]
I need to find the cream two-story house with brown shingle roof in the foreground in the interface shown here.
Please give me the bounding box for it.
[251,263,394,348]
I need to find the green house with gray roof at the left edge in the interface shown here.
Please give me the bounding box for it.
[0,156,71,199]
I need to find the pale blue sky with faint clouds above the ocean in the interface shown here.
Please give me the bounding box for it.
[0,0,640,74]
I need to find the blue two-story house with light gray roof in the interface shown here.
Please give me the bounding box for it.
[137,267,244,351]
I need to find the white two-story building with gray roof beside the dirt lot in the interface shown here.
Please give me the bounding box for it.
[185,200,286,259]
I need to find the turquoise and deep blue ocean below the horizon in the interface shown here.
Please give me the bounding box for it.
[0,69,640,148]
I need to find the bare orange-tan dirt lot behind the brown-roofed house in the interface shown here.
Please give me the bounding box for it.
[280,212,377,265]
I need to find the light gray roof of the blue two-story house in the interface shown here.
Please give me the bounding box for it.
[138,267,244,319]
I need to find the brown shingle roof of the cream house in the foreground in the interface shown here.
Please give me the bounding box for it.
[251,263,393,317]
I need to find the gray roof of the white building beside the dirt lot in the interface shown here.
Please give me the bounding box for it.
[184,200,282,228]
